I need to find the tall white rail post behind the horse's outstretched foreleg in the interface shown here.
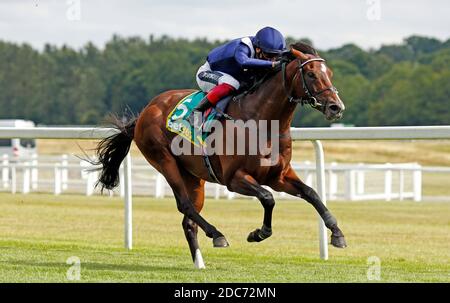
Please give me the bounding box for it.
[313,140,328,260]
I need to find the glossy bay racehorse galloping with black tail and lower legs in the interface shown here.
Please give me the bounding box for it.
[97,43,346,268]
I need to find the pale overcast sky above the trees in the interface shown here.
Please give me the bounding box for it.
[0,0,450,49]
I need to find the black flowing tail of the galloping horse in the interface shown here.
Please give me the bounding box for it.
[95,118,136,191]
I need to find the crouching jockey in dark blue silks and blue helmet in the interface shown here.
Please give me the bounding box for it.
[189,27,286,125]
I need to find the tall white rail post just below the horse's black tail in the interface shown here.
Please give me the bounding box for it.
[123,152,133,250]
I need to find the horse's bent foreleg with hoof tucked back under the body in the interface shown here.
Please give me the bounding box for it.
[229,171,275,242]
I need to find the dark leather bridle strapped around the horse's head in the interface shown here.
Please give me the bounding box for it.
[281,58,338,111]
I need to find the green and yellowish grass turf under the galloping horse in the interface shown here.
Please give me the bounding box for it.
[0,194,450,282]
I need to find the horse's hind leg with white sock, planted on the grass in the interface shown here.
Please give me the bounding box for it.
[181,177,205,269]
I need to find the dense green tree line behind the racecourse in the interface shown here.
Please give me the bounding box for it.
[0,36,450,126]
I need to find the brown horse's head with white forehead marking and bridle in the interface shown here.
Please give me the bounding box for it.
[283,44,345,120]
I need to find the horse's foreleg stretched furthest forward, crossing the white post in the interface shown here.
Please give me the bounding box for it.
[271,168,347,248]
